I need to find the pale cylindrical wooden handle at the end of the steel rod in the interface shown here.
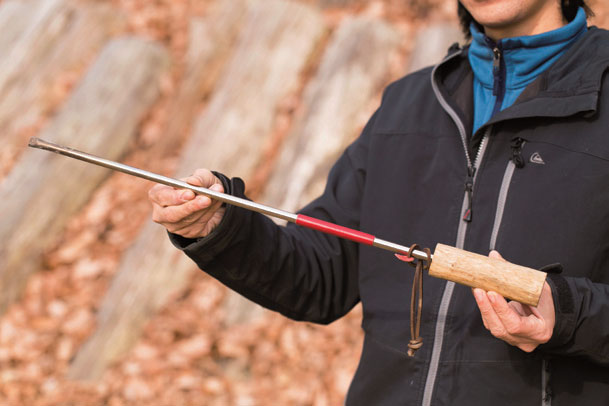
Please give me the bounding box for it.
[429,244,546,306]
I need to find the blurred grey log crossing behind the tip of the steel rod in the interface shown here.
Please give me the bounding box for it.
[0,37,169,313]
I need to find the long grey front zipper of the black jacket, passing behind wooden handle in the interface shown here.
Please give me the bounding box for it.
[422,52,491,406]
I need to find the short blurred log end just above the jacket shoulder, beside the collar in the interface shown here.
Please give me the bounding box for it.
[408,23,464,72]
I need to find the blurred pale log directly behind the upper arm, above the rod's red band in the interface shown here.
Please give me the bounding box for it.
[262,18,399,211]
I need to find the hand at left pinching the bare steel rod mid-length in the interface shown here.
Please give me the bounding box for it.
[148,169,226,238]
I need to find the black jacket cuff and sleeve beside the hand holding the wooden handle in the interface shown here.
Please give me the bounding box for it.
[540,275,609,366]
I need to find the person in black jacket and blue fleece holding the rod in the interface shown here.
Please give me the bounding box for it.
[149,0,609,406]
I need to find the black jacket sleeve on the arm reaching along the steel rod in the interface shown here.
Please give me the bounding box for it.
[170,110,375,323]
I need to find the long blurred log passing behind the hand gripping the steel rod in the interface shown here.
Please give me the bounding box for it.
[69,0,324,380]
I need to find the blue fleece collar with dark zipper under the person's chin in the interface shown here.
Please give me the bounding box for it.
[468,8,588,133]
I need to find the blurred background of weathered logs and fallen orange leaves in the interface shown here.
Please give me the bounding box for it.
[0,0,609,406]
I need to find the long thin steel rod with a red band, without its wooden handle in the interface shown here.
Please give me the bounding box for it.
[28,137,428,260]
